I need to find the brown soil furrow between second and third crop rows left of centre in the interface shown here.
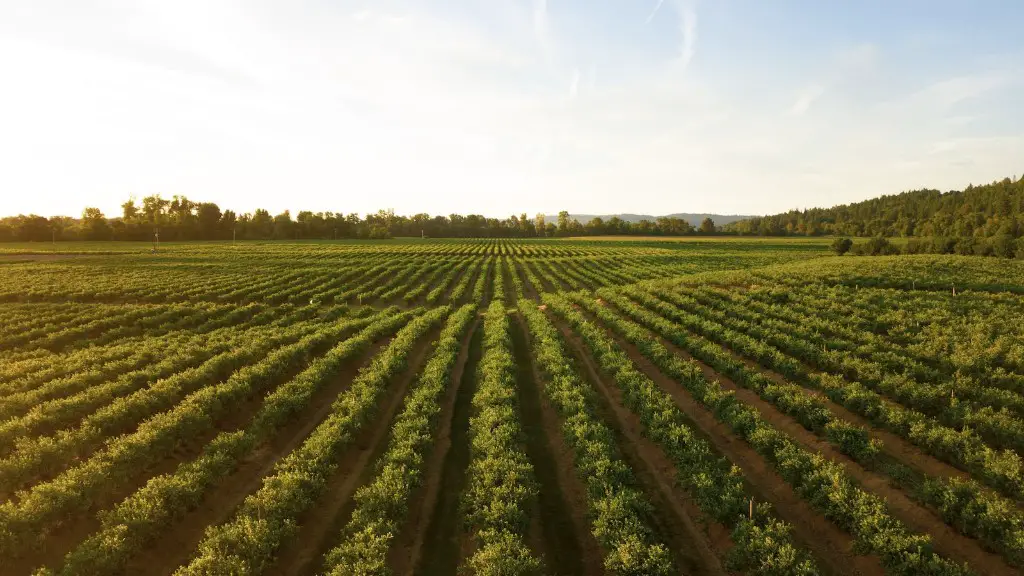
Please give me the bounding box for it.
[127,338,391,576]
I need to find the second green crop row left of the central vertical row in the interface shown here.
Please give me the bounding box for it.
[175,306,451,576]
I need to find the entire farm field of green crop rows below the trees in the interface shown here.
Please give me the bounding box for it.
[0,238,1024,576]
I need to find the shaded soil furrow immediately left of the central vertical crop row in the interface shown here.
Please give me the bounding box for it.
[412,326,483,576]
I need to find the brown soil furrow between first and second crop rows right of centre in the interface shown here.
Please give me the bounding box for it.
[551,317,731,575]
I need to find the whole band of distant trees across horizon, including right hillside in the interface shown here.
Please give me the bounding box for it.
[0,177,1024,248]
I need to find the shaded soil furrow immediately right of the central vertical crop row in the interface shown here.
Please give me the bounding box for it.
[512,315,604,576]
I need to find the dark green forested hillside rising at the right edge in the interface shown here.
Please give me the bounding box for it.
[724,178,1024,238]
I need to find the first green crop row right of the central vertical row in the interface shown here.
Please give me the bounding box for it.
[518,299,675,576]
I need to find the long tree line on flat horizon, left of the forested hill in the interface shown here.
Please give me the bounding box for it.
[0,195,718,242]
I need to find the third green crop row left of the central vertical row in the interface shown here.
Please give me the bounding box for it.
[58,307,415,576]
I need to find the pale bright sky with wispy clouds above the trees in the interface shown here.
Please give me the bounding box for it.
[0,0,1024,217]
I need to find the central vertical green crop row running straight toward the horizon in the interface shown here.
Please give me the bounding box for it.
[461,299,541,576]
